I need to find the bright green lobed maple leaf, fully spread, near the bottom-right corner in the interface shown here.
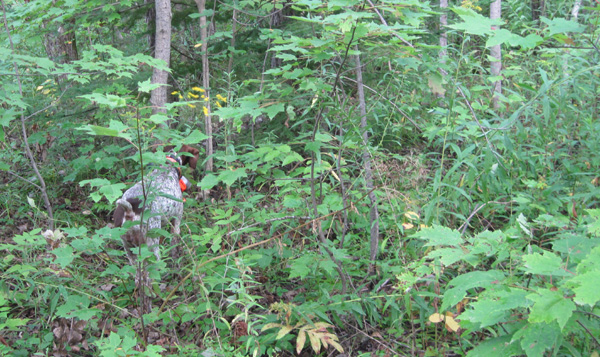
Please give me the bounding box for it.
[527,289,575,330]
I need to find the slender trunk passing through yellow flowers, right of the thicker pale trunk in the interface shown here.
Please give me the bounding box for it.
[195,0,213,172]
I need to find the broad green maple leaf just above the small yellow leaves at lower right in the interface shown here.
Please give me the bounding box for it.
[440,270,504,311]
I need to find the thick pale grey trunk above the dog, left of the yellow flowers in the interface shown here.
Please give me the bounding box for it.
[150,0,172,119]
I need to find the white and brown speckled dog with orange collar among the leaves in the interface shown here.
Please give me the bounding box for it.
[113,145,200,265]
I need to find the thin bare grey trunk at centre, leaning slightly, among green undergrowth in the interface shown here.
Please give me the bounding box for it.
[354,46,379,273]
